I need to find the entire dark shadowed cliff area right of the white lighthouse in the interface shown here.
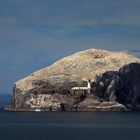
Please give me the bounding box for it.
[92,63,140,110]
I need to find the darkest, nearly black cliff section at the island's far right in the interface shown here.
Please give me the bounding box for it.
[116,63,140,109]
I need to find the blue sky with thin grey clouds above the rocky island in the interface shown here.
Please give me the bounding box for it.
[0,0,140,93]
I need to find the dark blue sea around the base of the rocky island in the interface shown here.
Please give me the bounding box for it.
[0,94,140,140]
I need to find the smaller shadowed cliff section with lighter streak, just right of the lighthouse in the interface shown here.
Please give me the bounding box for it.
[92,71,120,102]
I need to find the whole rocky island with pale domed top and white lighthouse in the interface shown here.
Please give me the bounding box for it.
[6,49,140,111]
